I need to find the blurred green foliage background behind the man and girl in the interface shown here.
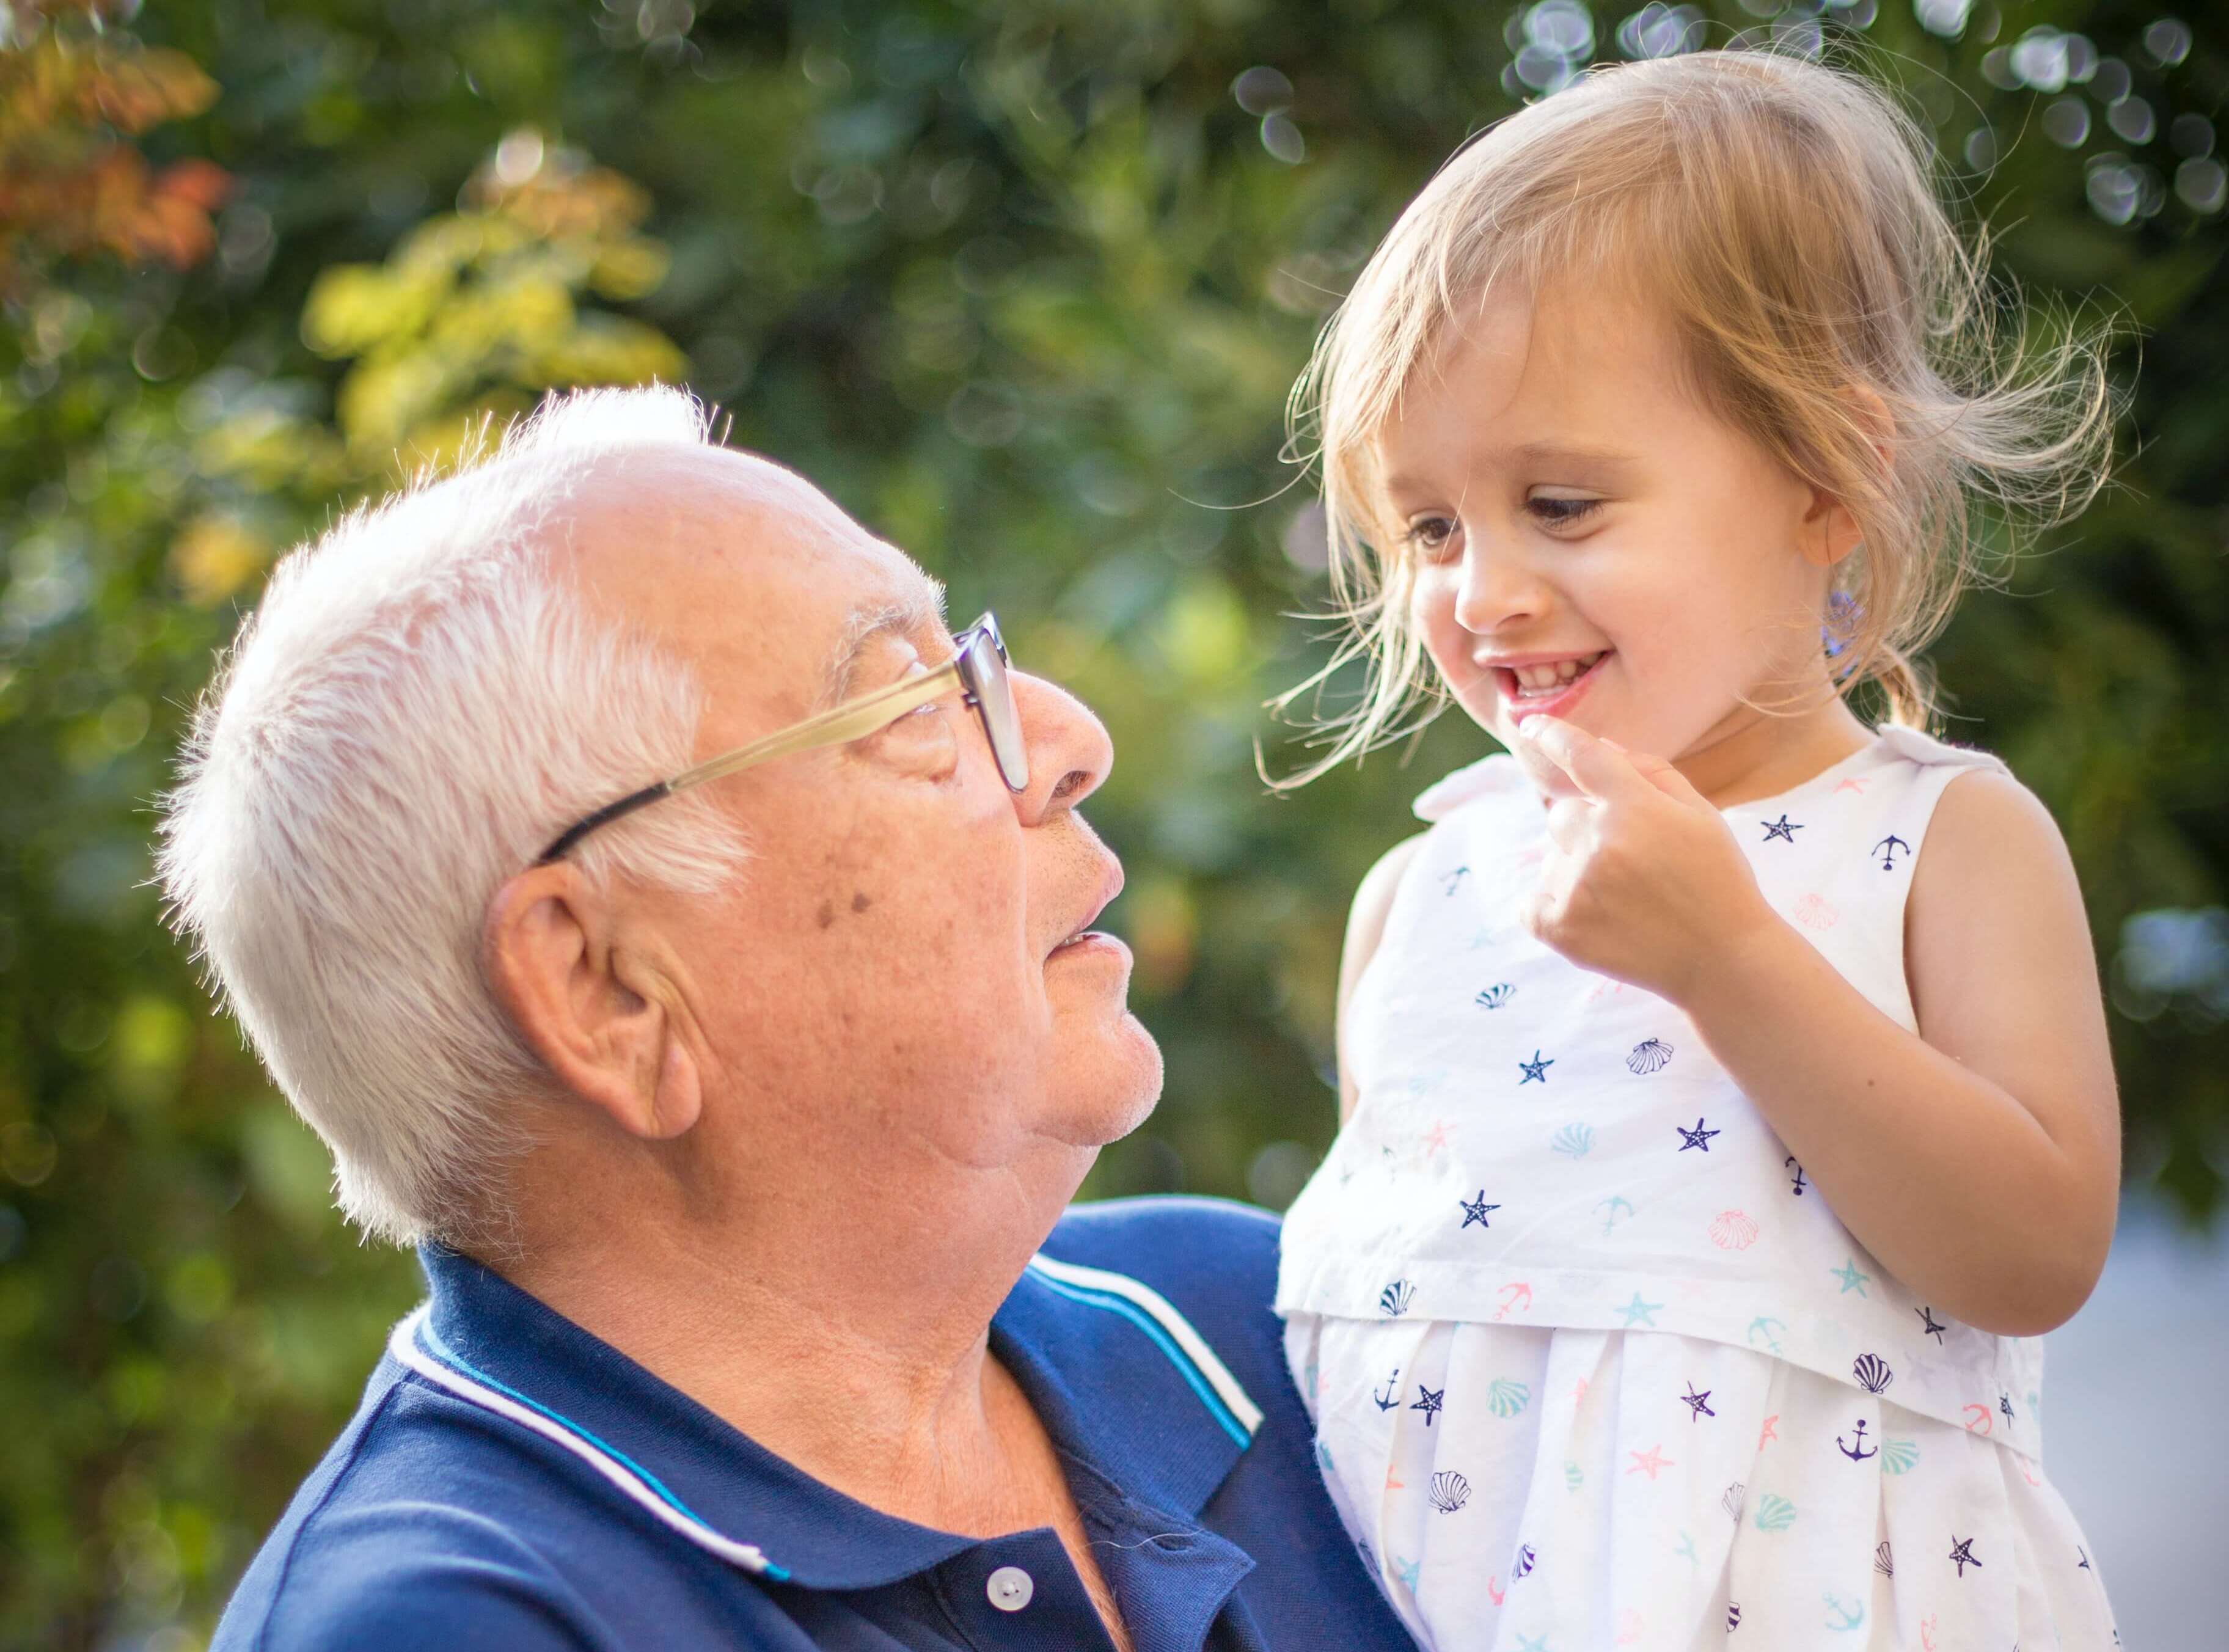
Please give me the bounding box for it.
[0,0,2229,1650]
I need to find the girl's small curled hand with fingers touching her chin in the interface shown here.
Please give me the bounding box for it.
[1518,718,1779,1003]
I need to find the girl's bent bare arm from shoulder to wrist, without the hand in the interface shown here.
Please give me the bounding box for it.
[1681,772,2120,1336]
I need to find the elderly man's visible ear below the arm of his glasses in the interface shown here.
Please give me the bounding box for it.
[481,861,705,1141]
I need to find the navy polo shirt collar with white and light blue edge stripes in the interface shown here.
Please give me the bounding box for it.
[395,1246,1251,1590]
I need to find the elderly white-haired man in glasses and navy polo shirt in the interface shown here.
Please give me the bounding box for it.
[163,390,1409,1652]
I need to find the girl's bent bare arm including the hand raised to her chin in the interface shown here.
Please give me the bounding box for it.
[1523,718,2120,1336]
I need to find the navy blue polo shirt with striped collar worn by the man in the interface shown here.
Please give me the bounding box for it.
[212,1199,1413,1652]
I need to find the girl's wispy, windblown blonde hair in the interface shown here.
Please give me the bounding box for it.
[1270,49,2122,787]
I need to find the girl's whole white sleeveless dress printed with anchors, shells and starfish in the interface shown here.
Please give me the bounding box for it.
[1277,727,2120,1652]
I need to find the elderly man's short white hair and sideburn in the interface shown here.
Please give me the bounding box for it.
[158,388,744,1244]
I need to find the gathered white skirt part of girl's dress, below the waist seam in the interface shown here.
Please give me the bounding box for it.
[1286,1315,2120,1652]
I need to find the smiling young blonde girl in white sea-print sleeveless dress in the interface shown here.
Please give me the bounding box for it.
[1277,51,2120,1652]
